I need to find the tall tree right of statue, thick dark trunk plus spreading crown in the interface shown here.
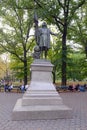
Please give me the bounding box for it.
[35,0,85,85]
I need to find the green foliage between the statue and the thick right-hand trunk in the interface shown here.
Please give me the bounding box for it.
[48,36,62,80]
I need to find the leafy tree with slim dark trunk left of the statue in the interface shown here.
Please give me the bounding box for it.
[0,0,34,84]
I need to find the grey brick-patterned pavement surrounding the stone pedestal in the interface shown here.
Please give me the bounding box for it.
[0,92,87,130]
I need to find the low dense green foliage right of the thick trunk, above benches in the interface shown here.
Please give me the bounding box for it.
[67,51,87,81]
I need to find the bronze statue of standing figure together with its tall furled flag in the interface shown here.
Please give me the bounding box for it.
[34,12,58,59]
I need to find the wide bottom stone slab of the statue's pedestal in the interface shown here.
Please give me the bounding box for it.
[12,99,72,120]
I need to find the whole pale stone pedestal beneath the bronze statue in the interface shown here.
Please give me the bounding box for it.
[12,59,72,120]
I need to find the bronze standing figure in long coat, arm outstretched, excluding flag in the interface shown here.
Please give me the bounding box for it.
[37,22,58,59]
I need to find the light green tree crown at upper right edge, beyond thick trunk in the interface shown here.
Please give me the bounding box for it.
[68,2,87,58]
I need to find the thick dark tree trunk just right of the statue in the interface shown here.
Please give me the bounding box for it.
[62,0,70,86]
